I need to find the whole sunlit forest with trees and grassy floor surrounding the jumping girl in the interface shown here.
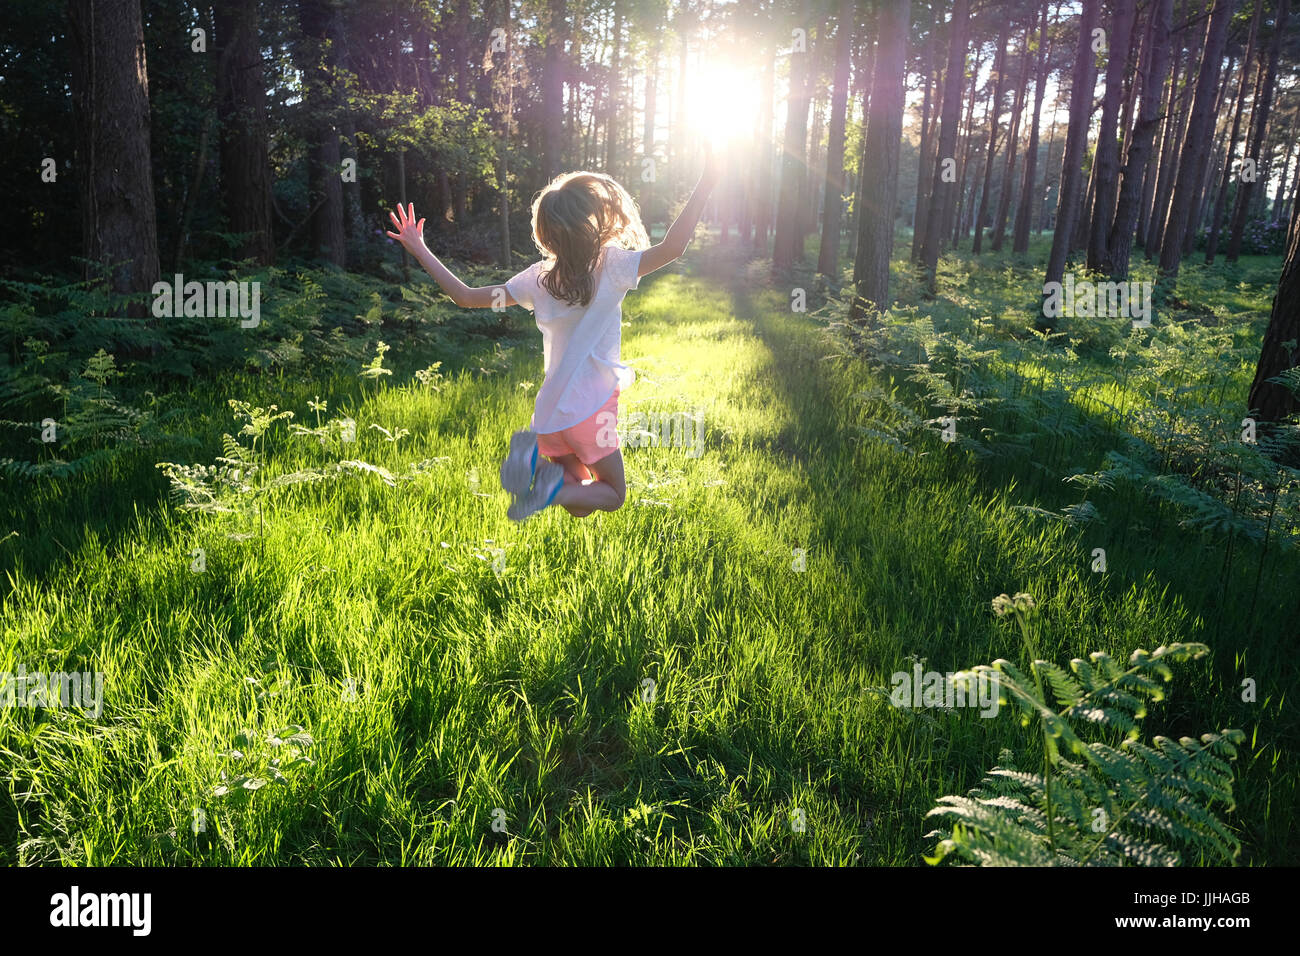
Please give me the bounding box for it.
[0,0,1300,866]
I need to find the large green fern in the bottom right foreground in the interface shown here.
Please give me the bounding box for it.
[926,594,1245,866]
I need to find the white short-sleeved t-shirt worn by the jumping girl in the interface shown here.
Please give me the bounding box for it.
[506,246,641,434]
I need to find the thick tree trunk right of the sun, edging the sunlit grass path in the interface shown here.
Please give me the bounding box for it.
[853,0,911,316]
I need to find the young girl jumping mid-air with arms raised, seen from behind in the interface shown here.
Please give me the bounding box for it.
[389,156,719,522]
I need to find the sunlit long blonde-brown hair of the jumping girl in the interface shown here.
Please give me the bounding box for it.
[533,172,650,306]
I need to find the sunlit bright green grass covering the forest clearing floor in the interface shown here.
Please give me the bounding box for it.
[0,243,1300,865]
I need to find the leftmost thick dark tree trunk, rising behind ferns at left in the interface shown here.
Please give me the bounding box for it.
[68,0,159,303]
